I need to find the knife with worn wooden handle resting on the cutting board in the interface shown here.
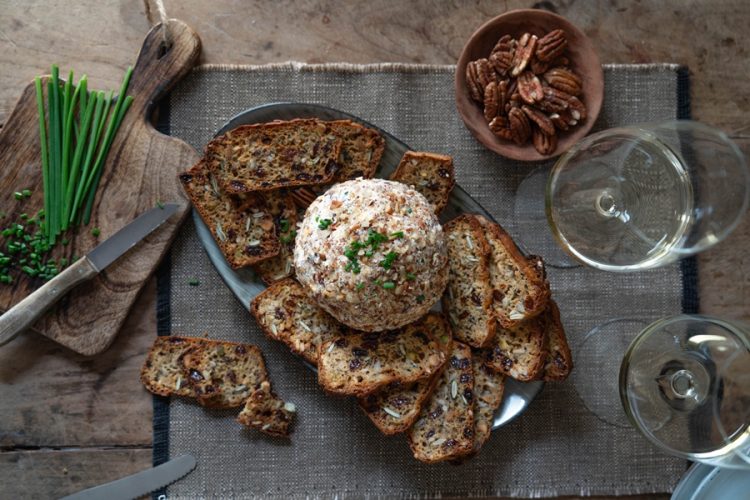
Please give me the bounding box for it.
[0,203,180,345]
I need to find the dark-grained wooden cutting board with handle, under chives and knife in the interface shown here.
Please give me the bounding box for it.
[0,19,201,355]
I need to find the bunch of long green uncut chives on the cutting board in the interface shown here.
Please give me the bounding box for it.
[35,65,133,245]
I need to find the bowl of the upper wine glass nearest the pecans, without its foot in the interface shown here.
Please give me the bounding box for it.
[544,121,750,271]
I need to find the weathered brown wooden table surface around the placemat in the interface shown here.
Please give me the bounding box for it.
[0,0,750,498]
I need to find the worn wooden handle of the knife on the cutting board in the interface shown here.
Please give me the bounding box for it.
[0,257,99,345]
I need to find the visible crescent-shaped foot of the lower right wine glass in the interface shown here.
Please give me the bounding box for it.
[570,318,648,427]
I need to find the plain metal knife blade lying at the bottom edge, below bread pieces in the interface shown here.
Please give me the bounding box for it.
[60,455,195,500]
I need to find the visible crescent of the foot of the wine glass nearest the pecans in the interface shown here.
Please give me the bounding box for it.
[514,167,582,268]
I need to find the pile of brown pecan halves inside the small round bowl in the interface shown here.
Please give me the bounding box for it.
[466,29,586,155]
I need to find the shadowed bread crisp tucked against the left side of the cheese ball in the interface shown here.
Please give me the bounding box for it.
[253,191,297,285]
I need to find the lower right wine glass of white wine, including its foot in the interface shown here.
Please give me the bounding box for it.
[571,315,750,469]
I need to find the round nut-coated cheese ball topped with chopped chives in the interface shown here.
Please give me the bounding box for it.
[294,179,448,332]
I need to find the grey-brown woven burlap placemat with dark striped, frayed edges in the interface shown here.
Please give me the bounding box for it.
[155,63,695,498]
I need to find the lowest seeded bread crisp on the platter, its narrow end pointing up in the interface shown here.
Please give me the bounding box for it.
[408,341,474,463]
